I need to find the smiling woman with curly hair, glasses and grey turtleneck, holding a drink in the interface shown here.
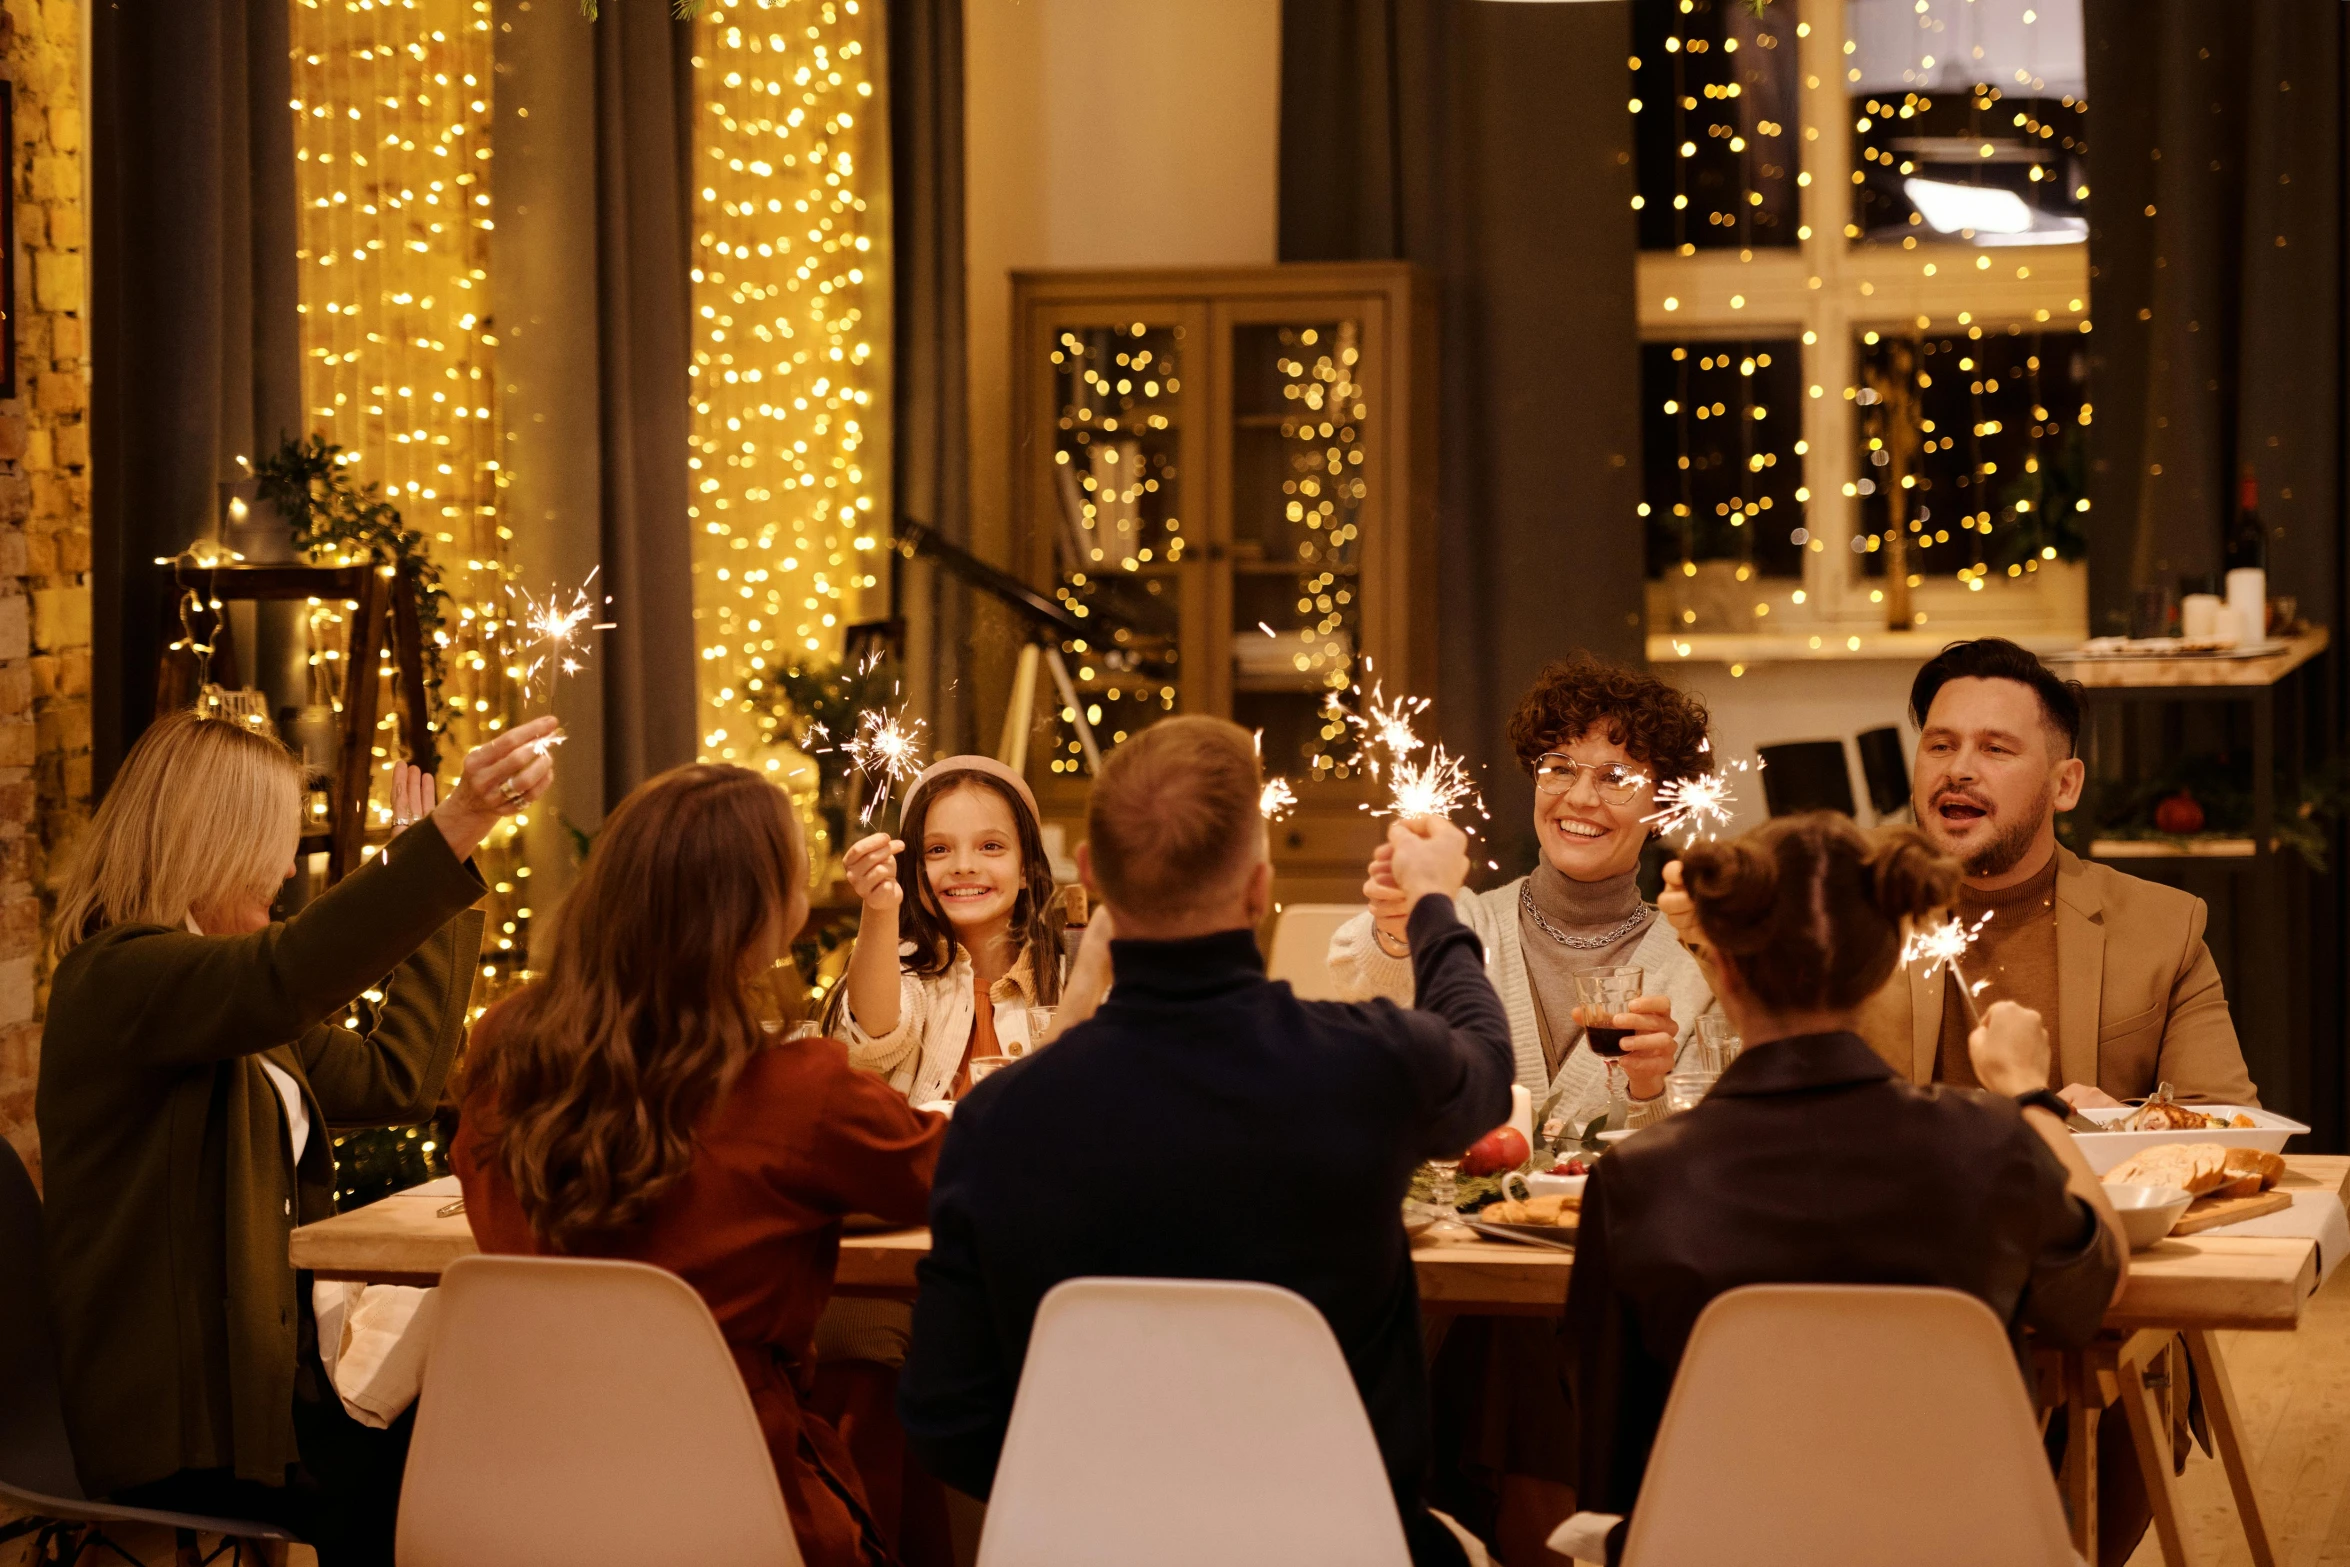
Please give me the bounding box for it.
[1330,653,1713,1135]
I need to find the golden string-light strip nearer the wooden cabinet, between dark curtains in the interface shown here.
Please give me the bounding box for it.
[695,0,891,761]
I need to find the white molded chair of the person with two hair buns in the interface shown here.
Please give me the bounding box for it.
[1551,1285,2080,1567]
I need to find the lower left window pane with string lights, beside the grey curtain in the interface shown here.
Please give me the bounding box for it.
[1640,338,1812,576]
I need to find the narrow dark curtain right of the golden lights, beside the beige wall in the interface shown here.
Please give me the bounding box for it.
[888,0,982,754]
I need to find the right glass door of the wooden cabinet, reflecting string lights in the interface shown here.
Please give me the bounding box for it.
[1220,305,1379,782]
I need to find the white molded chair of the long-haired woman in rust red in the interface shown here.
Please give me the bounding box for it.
[397,1257,799,1567]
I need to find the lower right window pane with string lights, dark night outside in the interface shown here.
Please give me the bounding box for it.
[1852,331,2089,580]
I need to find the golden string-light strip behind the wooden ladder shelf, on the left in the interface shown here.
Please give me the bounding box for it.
[289,0,529,972]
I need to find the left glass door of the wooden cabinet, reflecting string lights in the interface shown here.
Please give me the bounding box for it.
[1032,312,1206,775]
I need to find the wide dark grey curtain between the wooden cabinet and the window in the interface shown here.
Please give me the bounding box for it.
[1281,0,1645,860]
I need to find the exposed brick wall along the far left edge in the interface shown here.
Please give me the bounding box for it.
[0,0,89,1177]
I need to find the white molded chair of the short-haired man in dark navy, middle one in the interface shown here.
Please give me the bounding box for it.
[978,1278,1410,1567]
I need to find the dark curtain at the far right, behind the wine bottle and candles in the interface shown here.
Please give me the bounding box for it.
[2087,0,2350,1149]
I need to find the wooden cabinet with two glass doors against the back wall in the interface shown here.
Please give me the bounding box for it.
[1013,263,1436,900]
